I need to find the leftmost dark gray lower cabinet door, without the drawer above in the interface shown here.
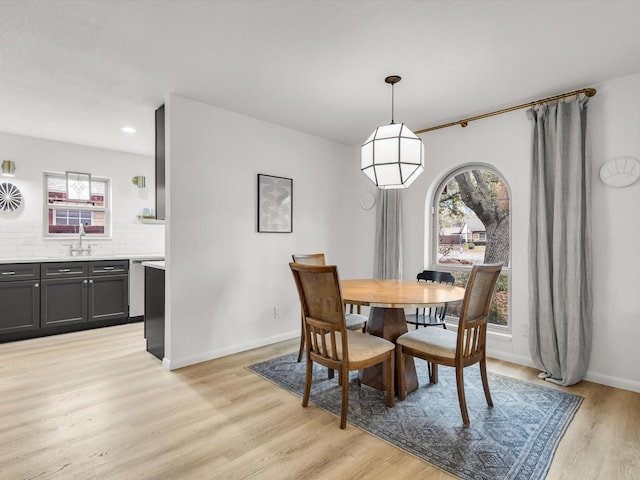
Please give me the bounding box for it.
[0,280,40,334]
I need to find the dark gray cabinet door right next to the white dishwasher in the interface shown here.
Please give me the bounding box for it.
[89,275,129,321]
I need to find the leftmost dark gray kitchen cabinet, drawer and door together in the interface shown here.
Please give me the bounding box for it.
[0,263,40,334]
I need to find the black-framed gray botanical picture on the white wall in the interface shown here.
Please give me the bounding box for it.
[257,173,293,233]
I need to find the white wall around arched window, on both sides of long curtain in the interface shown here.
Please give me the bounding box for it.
[404,75,640,391]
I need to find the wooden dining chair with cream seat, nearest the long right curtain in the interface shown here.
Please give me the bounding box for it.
[396,263,502,426]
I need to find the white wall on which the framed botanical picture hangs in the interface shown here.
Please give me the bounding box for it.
[164,95,370,369]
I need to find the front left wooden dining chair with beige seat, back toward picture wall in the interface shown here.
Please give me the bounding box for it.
[289,262,395,428]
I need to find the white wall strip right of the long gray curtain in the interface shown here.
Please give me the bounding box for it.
[587,74,640,392]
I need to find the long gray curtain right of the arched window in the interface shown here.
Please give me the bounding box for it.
[527,97,592,385]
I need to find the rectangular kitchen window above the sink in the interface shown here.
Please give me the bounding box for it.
[43,172,111,238]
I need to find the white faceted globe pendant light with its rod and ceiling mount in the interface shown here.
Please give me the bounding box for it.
[361,75,424,189]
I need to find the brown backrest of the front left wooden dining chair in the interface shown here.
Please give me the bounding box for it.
[289,262,349,368]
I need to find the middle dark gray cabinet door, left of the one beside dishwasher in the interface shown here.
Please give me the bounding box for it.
[40,278,88,327]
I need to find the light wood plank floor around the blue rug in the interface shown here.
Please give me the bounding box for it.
[0,323,640,480]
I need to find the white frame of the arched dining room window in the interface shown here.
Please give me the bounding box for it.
[425,163,513,334]
